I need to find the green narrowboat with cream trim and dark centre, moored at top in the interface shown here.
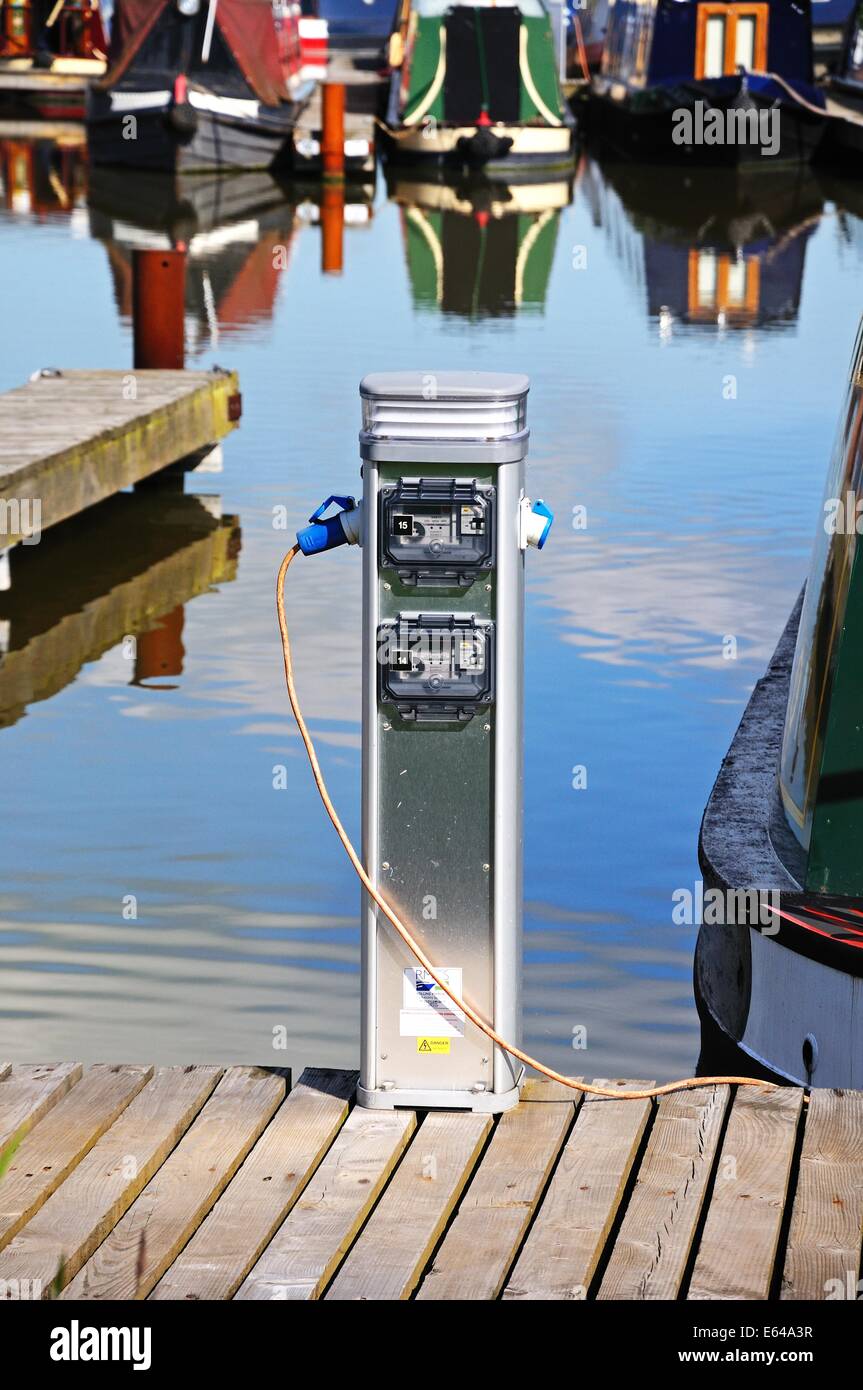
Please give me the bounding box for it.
[381,0,574,182]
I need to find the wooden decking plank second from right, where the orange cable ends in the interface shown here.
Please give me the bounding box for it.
[688,1086,803,1300]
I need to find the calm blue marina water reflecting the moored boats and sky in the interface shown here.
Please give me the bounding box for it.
[0,146,863,1079]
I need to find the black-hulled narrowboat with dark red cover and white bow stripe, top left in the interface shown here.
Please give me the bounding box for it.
[86,0,313,172]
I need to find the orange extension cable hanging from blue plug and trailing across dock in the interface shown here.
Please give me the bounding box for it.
[275,545,770,1101]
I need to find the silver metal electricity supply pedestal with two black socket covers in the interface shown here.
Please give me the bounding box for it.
[351,373,552,1112]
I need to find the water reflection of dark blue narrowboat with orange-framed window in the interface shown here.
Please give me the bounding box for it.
[580,163,824,335]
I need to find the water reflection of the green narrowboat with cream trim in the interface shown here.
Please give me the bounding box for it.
[389,170,573,318]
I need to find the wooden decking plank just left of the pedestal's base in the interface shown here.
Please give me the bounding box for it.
[150,1068,357,1300]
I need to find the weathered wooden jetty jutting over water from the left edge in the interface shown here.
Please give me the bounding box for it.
[0,368,240,550]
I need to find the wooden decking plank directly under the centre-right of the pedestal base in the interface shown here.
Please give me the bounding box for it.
[325,1112,492,1300]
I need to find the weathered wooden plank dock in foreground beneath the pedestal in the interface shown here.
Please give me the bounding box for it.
[0,1063,863,1301]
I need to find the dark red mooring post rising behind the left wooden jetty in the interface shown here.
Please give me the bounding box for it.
[132,249,186,370]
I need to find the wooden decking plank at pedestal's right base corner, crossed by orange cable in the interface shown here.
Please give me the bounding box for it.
[417,1081,580,1301]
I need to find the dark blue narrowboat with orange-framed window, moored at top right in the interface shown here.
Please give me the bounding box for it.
[588,0,825,171]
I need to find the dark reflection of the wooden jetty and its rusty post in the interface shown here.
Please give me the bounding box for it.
[0,489,240,728]
